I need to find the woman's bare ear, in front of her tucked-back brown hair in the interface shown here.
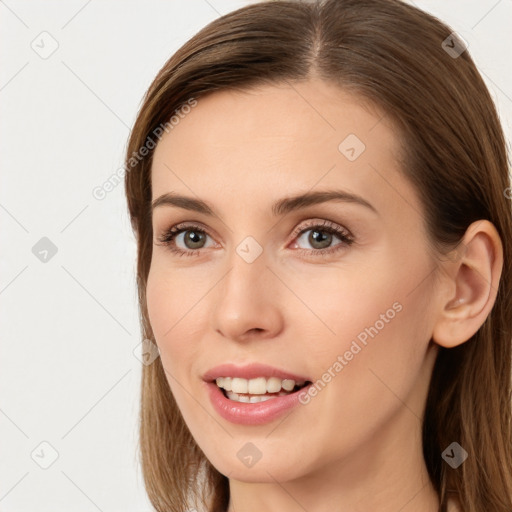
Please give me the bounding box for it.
[432,220,503,348]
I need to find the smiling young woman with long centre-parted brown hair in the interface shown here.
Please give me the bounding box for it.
[126,0,512,512]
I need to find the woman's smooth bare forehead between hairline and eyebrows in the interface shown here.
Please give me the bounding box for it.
[152,81,419,223]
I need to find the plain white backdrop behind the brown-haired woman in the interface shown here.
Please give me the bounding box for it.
[0,0,512,512]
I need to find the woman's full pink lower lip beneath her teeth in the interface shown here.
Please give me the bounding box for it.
[205,382,312,425]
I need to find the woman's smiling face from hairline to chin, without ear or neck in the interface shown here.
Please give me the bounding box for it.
[147,80,437,488]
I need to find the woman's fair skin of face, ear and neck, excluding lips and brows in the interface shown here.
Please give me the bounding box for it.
[147,80,502,512]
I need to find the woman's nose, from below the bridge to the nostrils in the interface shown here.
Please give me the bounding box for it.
[213,245,283,341]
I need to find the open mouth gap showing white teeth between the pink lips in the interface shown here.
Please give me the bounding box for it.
[210,377,312,404]
